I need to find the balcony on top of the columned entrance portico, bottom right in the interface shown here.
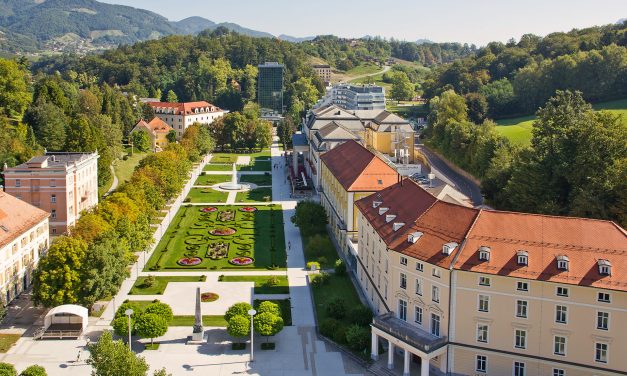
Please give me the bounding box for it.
[371,312,448,354]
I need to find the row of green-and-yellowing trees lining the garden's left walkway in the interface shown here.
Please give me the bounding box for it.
[33,125,213,307]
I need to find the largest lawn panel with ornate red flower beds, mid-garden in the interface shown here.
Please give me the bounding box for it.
[147,204,286,271]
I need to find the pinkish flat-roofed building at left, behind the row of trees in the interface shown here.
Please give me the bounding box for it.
[4,153,98,236]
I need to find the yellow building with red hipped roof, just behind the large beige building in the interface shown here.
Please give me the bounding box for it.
[320,140,398,267]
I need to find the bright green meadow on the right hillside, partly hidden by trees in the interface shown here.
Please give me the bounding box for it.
[496,99,627,145]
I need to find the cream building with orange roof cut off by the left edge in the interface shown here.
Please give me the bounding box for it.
[0,192,49,305]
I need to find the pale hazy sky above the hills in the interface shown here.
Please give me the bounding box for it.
[100,0,627,44]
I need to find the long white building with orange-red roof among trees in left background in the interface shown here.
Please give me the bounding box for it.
[148,101,226,139]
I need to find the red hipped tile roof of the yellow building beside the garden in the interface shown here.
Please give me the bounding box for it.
[320,140,398,192]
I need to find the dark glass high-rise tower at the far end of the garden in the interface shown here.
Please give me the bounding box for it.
[257,63,283,114]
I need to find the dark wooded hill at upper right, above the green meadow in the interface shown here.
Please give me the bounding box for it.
[423,22,627,120]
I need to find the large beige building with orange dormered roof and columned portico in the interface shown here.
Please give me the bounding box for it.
[356,179,627,376]
